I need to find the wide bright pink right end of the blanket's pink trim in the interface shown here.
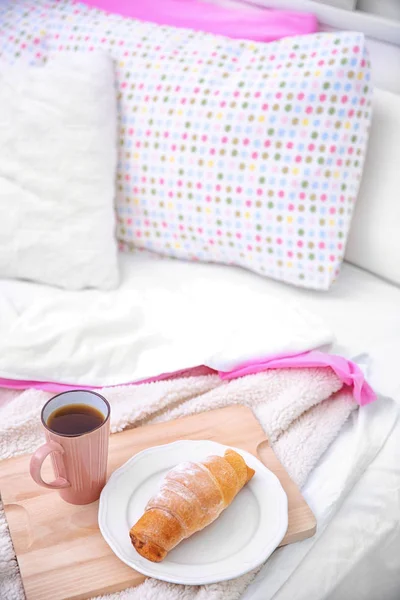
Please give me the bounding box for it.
[219,350,376,406]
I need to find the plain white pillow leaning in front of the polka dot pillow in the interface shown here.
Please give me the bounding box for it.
[0,52,119,289]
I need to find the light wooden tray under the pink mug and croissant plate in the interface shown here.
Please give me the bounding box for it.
[0,406,316,600]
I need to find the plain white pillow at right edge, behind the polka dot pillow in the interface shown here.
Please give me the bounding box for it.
[345,89,400,284]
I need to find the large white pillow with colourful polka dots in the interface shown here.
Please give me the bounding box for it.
[0,0,371,289]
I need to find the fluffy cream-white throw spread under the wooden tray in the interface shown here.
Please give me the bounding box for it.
[0,368,357,600]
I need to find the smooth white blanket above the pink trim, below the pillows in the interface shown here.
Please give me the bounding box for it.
[0,254,333,387]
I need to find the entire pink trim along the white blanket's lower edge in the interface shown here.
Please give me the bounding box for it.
[0,350,376,406]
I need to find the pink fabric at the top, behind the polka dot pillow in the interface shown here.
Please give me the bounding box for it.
[77,0,318,42]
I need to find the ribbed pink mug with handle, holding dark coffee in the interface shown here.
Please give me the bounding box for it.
[30,390,110,504]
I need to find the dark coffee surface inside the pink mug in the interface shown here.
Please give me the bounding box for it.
[47,404,104,435]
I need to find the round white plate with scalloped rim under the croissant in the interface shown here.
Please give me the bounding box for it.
[99,440,288,585]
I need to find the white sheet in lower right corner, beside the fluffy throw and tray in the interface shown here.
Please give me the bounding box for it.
[243,399,400,600]
